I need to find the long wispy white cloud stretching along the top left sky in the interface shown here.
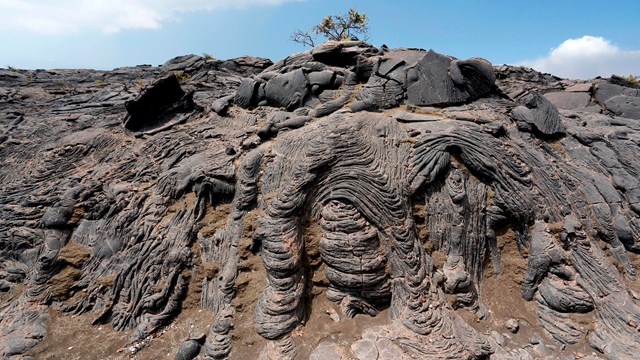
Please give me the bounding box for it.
[0,0,295,34]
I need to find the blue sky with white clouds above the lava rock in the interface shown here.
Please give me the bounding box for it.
[0,0,640,78]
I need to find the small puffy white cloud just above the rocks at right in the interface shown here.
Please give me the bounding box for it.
[518,35,640,79]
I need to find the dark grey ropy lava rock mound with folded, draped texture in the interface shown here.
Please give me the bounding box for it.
[0,42,640,359]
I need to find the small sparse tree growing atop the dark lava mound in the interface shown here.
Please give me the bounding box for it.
[291,9,369,47]
